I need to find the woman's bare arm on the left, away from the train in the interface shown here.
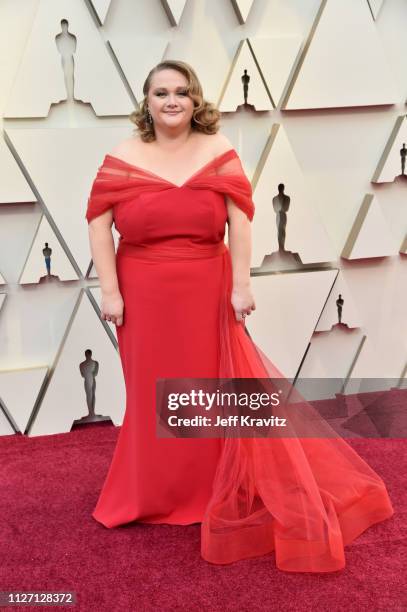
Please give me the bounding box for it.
[88,209,124,325]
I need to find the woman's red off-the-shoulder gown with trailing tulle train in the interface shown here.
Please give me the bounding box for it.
[86,149,393,572]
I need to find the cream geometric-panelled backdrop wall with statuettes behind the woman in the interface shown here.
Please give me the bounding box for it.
[0,0,407,436]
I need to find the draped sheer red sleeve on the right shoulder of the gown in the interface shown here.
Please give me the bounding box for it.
[191,149,255,221]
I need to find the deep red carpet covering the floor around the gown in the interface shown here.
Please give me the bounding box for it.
[0,423,407,612]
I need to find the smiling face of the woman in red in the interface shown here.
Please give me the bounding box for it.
[147,68,194,130]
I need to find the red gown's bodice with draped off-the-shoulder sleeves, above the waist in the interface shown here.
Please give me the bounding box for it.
[86,149,254,244]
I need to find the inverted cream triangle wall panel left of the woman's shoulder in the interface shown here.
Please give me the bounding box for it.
[7,127,131,274]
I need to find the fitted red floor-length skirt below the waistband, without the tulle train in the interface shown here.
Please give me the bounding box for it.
[93,245,223,527]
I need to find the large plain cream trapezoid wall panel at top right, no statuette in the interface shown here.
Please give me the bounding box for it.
[283,0,400,110]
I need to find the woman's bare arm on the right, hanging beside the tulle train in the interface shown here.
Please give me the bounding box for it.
[226,197,256,321]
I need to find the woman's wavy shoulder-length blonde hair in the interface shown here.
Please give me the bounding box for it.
[130,60,220,142]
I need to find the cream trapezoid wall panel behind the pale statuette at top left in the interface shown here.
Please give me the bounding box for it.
[5,0,133,117]
